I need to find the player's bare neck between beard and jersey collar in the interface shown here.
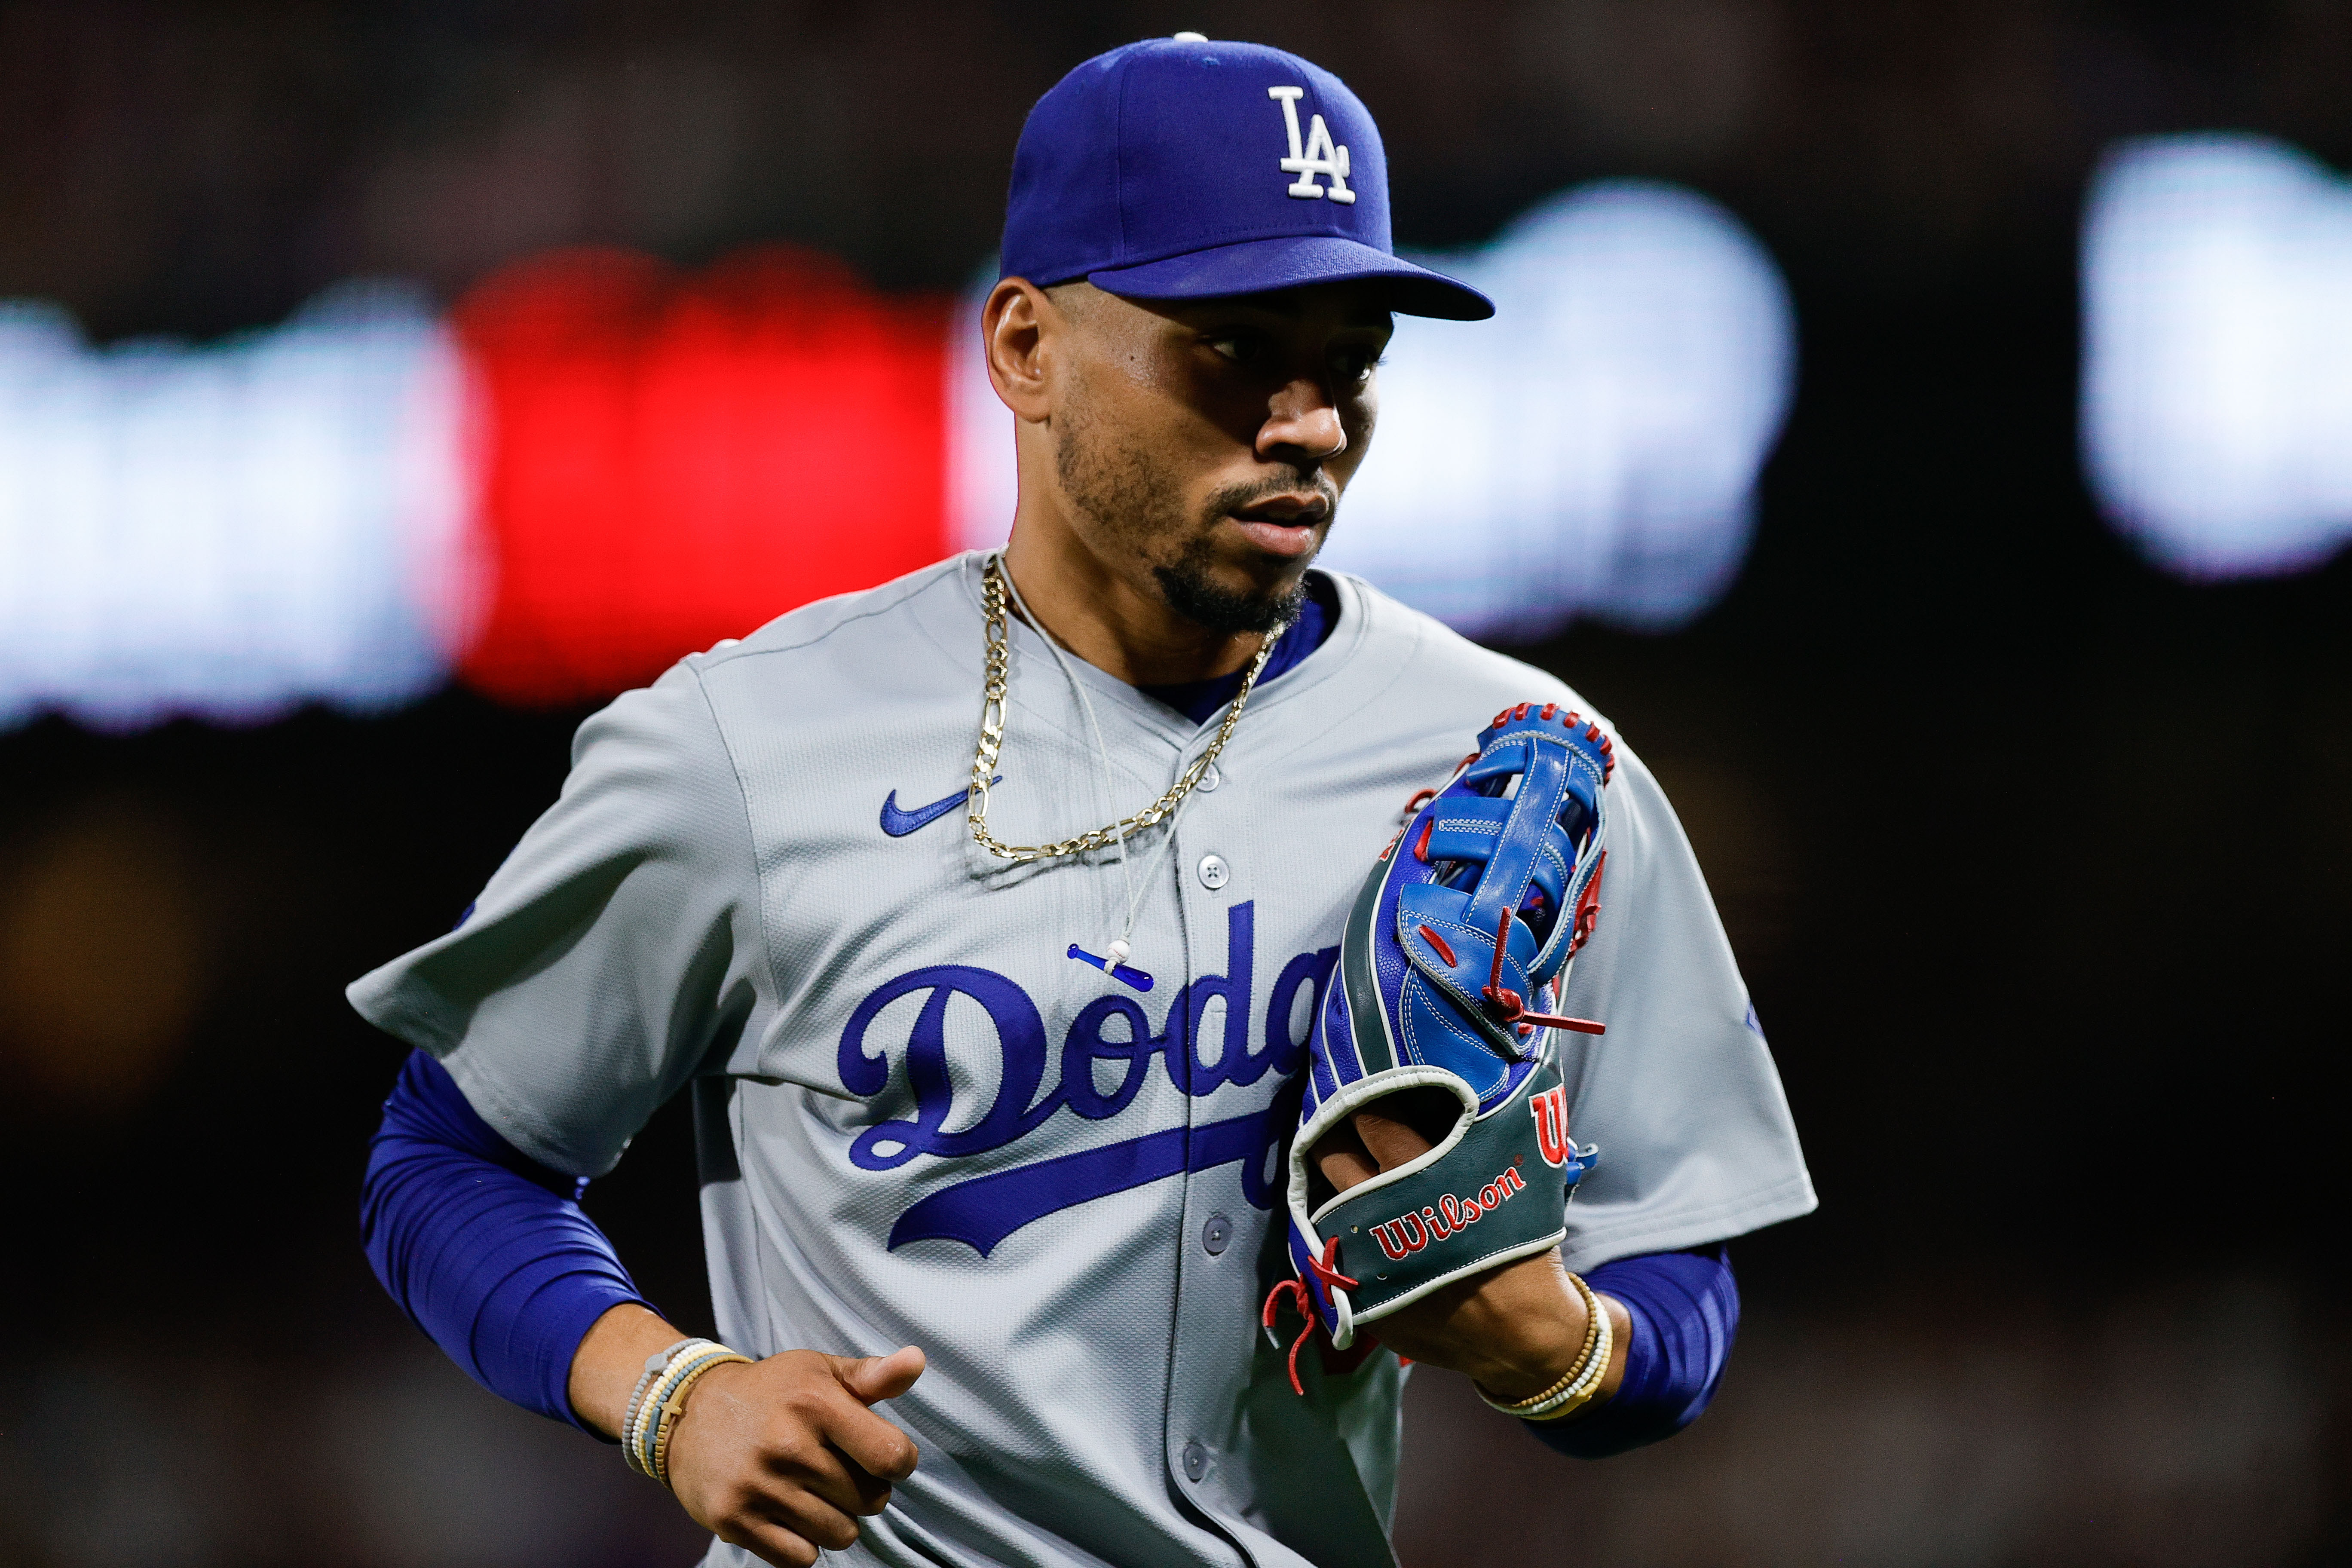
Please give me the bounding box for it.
[1004,512,1265,686]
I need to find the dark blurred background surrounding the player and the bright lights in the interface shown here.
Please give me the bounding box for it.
[0,0,2352,1568]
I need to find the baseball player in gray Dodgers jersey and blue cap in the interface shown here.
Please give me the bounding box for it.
[350,33,1813,1568]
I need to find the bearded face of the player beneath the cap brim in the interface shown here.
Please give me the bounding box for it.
[1051,285,1392,632]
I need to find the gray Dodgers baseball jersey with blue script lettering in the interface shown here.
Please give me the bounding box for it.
[350,555,1813,1568]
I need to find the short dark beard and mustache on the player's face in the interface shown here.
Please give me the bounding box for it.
[1054,400,1338,637]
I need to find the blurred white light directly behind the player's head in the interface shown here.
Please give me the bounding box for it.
[950,181,1795,637]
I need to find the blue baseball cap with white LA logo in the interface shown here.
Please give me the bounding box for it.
[1002,33,1494,322]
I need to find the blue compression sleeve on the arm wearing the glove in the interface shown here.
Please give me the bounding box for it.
[1526,1246,1740,1460]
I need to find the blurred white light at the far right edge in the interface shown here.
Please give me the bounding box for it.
[2082,136,2352,578]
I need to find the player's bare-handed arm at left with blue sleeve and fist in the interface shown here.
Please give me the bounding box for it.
[360,1051,922,1568]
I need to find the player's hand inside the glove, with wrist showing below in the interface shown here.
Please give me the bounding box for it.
[1315,1096,1632,1403]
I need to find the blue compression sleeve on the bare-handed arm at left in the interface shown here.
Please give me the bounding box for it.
[360,1051,649,1432]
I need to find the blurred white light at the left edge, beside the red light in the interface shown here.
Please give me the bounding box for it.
[0,285,480,726]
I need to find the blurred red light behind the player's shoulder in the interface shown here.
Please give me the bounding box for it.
[454,247,950,703]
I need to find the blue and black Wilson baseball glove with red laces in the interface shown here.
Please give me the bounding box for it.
[1263,703,1616,1392]
